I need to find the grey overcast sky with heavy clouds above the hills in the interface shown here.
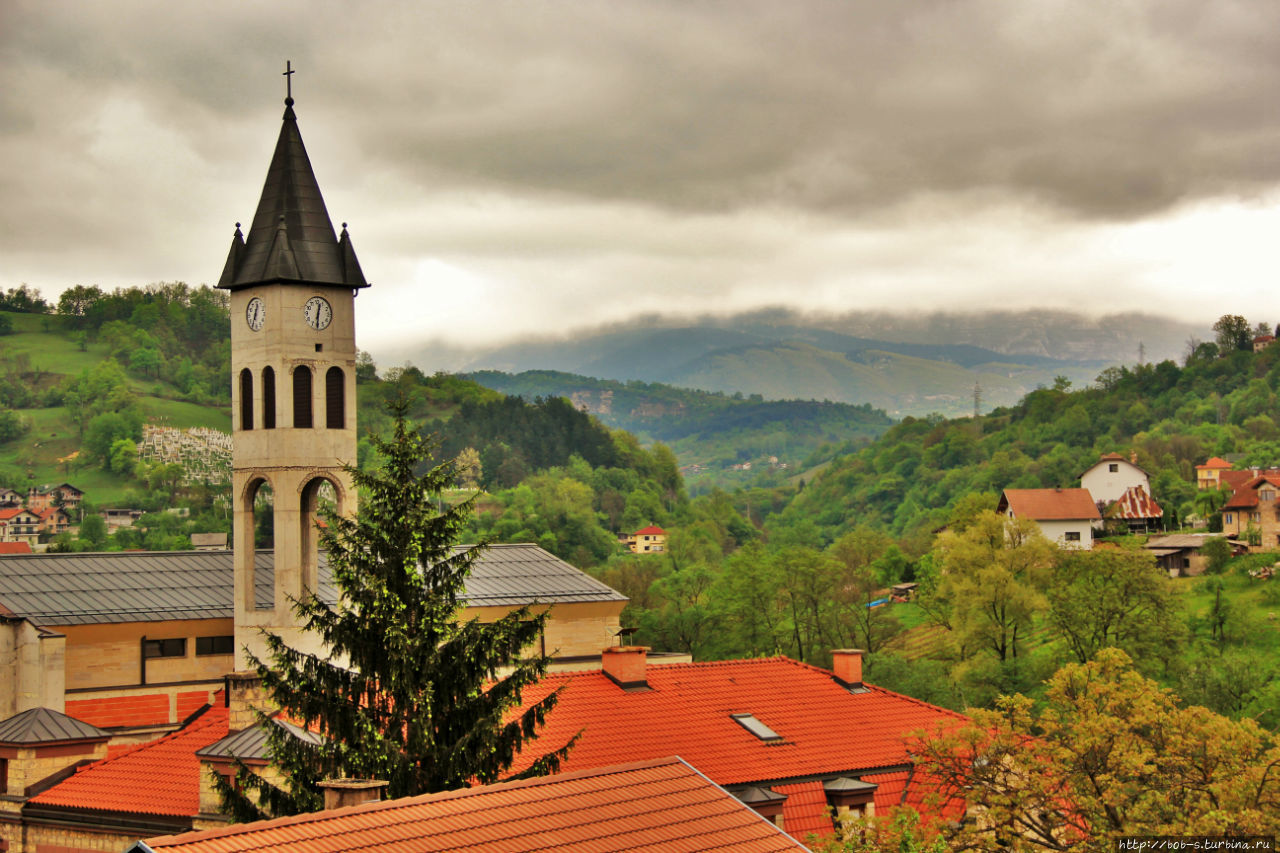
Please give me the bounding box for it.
[0,0,1280,356]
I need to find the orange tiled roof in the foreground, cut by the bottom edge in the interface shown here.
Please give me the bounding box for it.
[146,757,798,853]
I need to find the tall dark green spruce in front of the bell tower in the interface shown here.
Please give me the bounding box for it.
[215,400,573,820]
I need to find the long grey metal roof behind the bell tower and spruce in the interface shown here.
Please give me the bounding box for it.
[0,544,626,625]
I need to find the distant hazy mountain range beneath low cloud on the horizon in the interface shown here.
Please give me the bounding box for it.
[374,309,1212,416]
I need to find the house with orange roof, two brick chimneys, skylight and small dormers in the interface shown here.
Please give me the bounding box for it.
[499,647,964,839]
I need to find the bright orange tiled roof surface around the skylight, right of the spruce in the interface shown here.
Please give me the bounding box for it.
[504,657,964,786]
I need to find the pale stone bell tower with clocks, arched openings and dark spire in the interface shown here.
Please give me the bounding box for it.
[218,69,369,670]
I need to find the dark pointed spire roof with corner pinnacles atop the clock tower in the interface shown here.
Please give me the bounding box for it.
[218,99,369,291]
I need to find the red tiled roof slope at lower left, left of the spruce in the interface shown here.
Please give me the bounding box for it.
[29,703,227,817]
